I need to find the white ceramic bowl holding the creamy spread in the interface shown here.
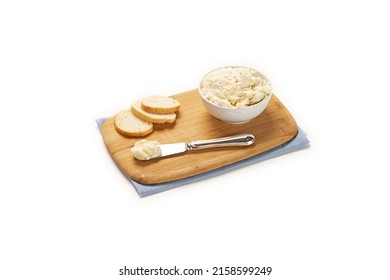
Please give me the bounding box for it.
[198,66,272,124]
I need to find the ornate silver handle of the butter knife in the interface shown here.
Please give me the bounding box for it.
[186,133,255,150]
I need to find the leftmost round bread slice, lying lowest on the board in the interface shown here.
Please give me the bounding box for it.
[114,110,153,137]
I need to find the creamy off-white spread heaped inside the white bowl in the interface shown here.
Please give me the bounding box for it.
[200,67,271,108]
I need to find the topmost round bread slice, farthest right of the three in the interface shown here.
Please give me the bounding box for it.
[141,95,180,114]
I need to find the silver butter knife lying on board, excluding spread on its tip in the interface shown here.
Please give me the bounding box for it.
[158,133,255,157]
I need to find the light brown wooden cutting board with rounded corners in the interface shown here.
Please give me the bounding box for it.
[102,89,298,184]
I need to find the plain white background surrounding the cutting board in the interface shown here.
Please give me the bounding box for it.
[0,0,390,280]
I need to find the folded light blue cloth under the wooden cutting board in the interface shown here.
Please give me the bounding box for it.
[96,118,310,197]
